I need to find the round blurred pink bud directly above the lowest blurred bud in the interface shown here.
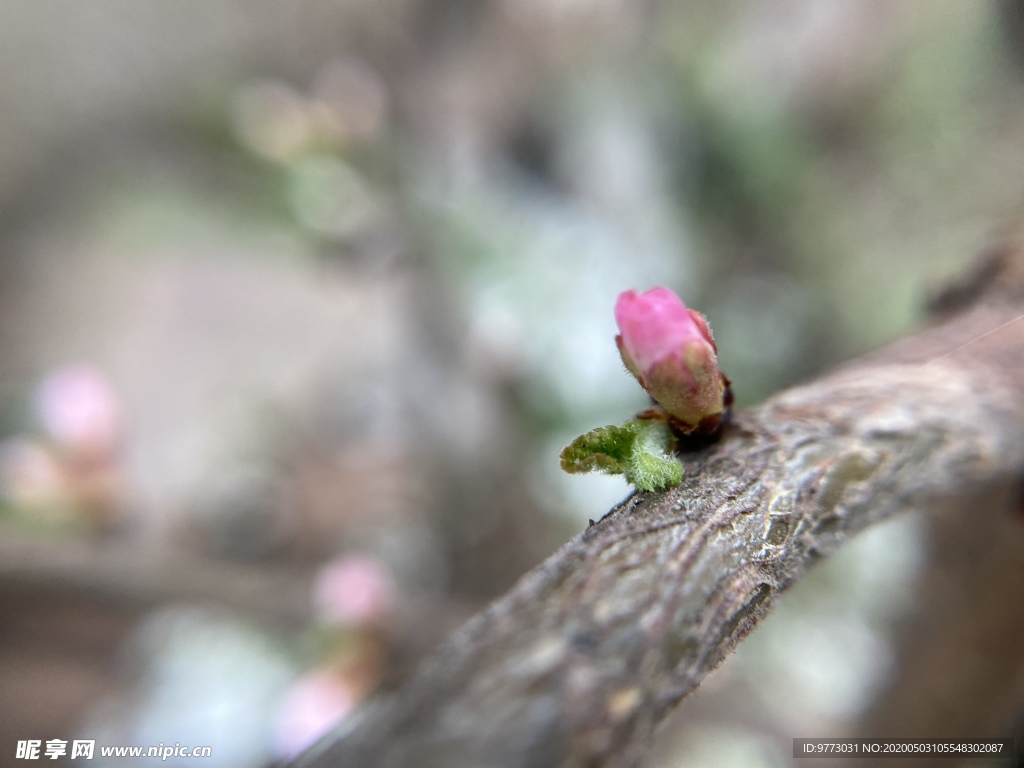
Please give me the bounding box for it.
[313,555,394,625]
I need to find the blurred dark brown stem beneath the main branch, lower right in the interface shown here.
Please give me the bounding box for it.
[855,486,1024,768]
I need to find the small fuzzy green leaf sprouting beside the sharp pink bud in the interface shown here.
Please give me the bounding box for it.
[562,419,683,490]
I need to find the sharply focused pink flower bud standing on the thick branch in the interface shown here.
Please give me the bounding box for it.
[615,288,725,430]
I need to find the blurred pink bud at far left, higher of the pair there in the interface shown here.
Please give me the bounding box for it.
[36,366,121,453]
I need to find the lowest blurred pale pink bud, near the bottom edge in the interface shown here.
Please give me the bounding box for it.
[274,672,358,760]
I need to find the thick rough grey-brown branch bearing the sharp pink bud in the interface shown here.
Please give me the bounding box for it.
[296,243,1024,768]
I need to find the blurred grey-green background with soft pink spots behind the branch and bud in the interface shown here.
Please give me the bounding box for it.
[0,0,1024,768]
